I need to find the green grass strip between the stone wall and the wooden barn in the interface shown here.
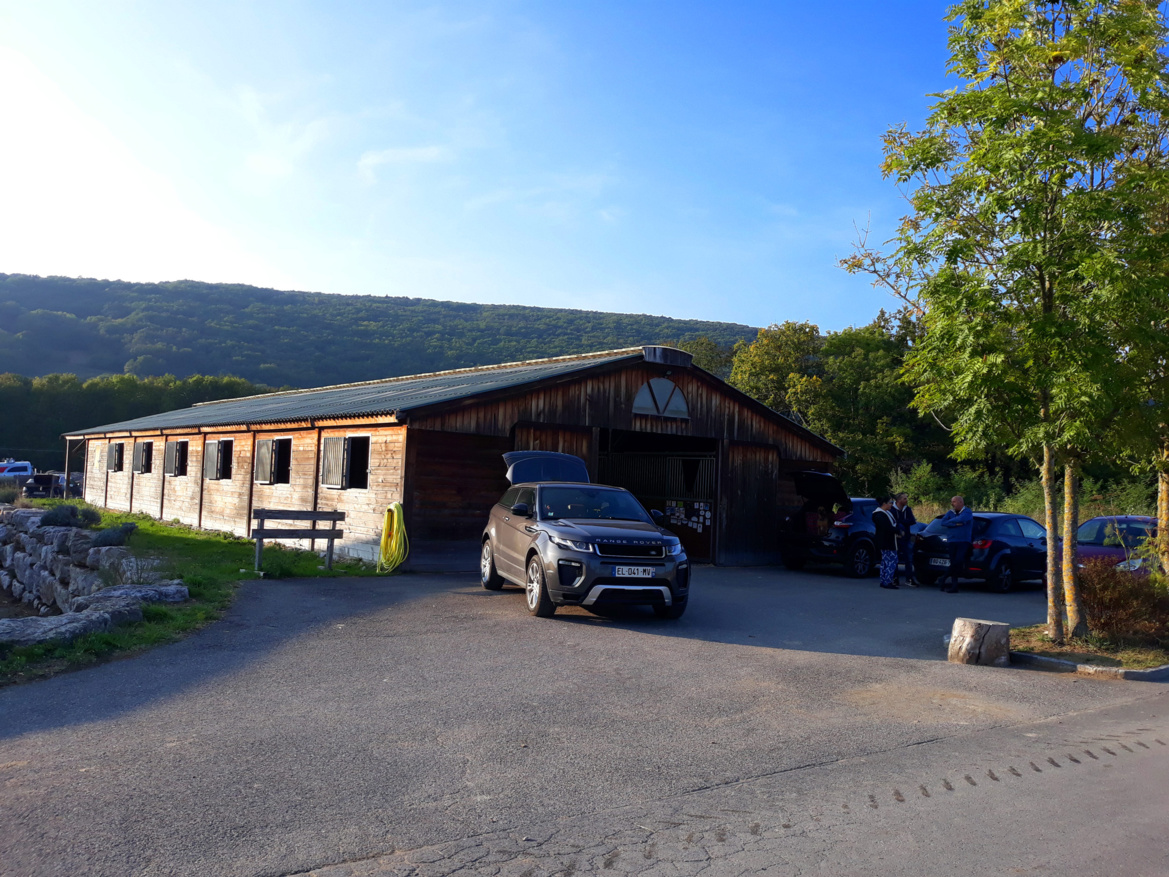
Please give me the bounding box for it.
[0,499,378,685]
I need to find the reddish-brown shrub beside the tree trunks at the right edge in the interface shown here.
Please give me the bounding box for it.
[1080,558,1169,641]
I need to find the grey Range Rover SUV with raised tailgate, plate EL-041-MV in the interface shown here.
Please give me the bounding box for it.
[479,451,690,619]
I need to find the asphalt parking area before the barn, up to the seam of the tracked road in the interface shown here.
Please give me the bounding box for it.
[0,568,1169,875]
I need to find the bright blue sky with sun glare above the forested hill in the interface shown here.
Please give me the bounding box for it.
[0,0,947,329]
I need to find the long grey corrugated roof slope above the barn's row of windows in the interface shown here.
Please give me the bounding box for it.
[67,347,643,436]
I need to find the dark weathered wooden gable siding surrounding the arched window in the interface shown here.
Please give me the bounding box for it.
[409,364,836,464]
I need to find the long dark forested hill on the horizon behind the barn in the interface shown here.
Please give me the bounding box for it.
[0,274,755,387]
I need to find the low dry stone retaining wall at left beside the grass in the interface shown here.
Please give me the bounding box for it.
[0,506,188,647]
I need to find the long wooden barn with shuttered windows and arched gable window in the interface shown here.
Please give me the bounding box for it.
[67,347,842,568]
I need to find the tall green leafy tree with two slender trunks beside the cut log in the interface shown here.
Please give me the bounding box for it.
[843,0,1169,640]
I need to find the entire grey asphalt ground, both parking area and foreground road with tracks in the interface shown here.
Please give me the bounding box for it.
[0,568,1169,877]
